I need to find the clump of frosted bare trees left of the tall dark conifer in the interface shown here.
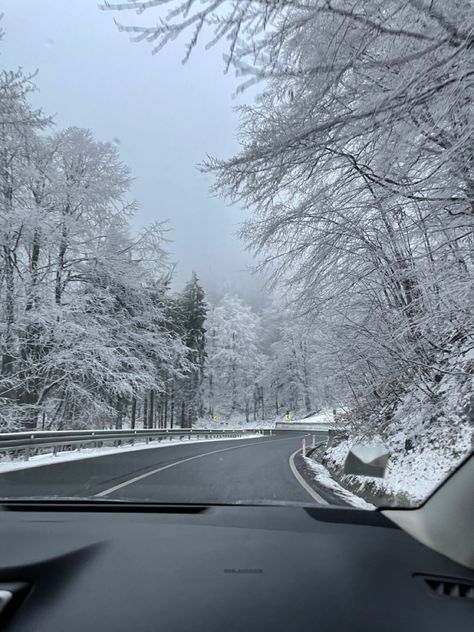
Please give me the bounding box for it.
[0,56,189,428]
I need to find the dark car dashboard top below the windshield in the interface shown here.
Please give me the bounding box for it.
[0,505,474,632]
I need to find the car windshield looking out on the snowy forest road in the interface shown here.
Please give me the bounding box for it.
[0,0,474,509]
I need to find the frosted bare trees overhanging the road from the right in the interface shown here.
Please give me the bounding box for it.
[103,0,474,460]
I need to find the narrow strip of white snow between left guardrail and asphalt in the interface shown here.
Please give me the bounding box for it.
[0,433,260,474]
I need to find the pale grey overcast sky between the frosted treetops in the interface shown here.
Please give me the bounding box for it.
[0,0,262,298]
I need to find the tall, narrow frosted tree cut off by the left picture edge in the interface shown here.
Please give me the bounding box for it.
[0,65,50,430]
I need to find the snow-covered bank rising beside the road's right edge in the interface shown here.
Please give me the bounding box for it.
[323,349,474,506]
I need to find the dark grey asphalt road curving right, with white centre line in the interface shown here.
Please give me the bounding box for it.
[0,432,334,503]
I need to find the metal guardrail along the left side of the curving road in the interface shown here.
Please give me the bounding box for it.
[0,428,272,461]
